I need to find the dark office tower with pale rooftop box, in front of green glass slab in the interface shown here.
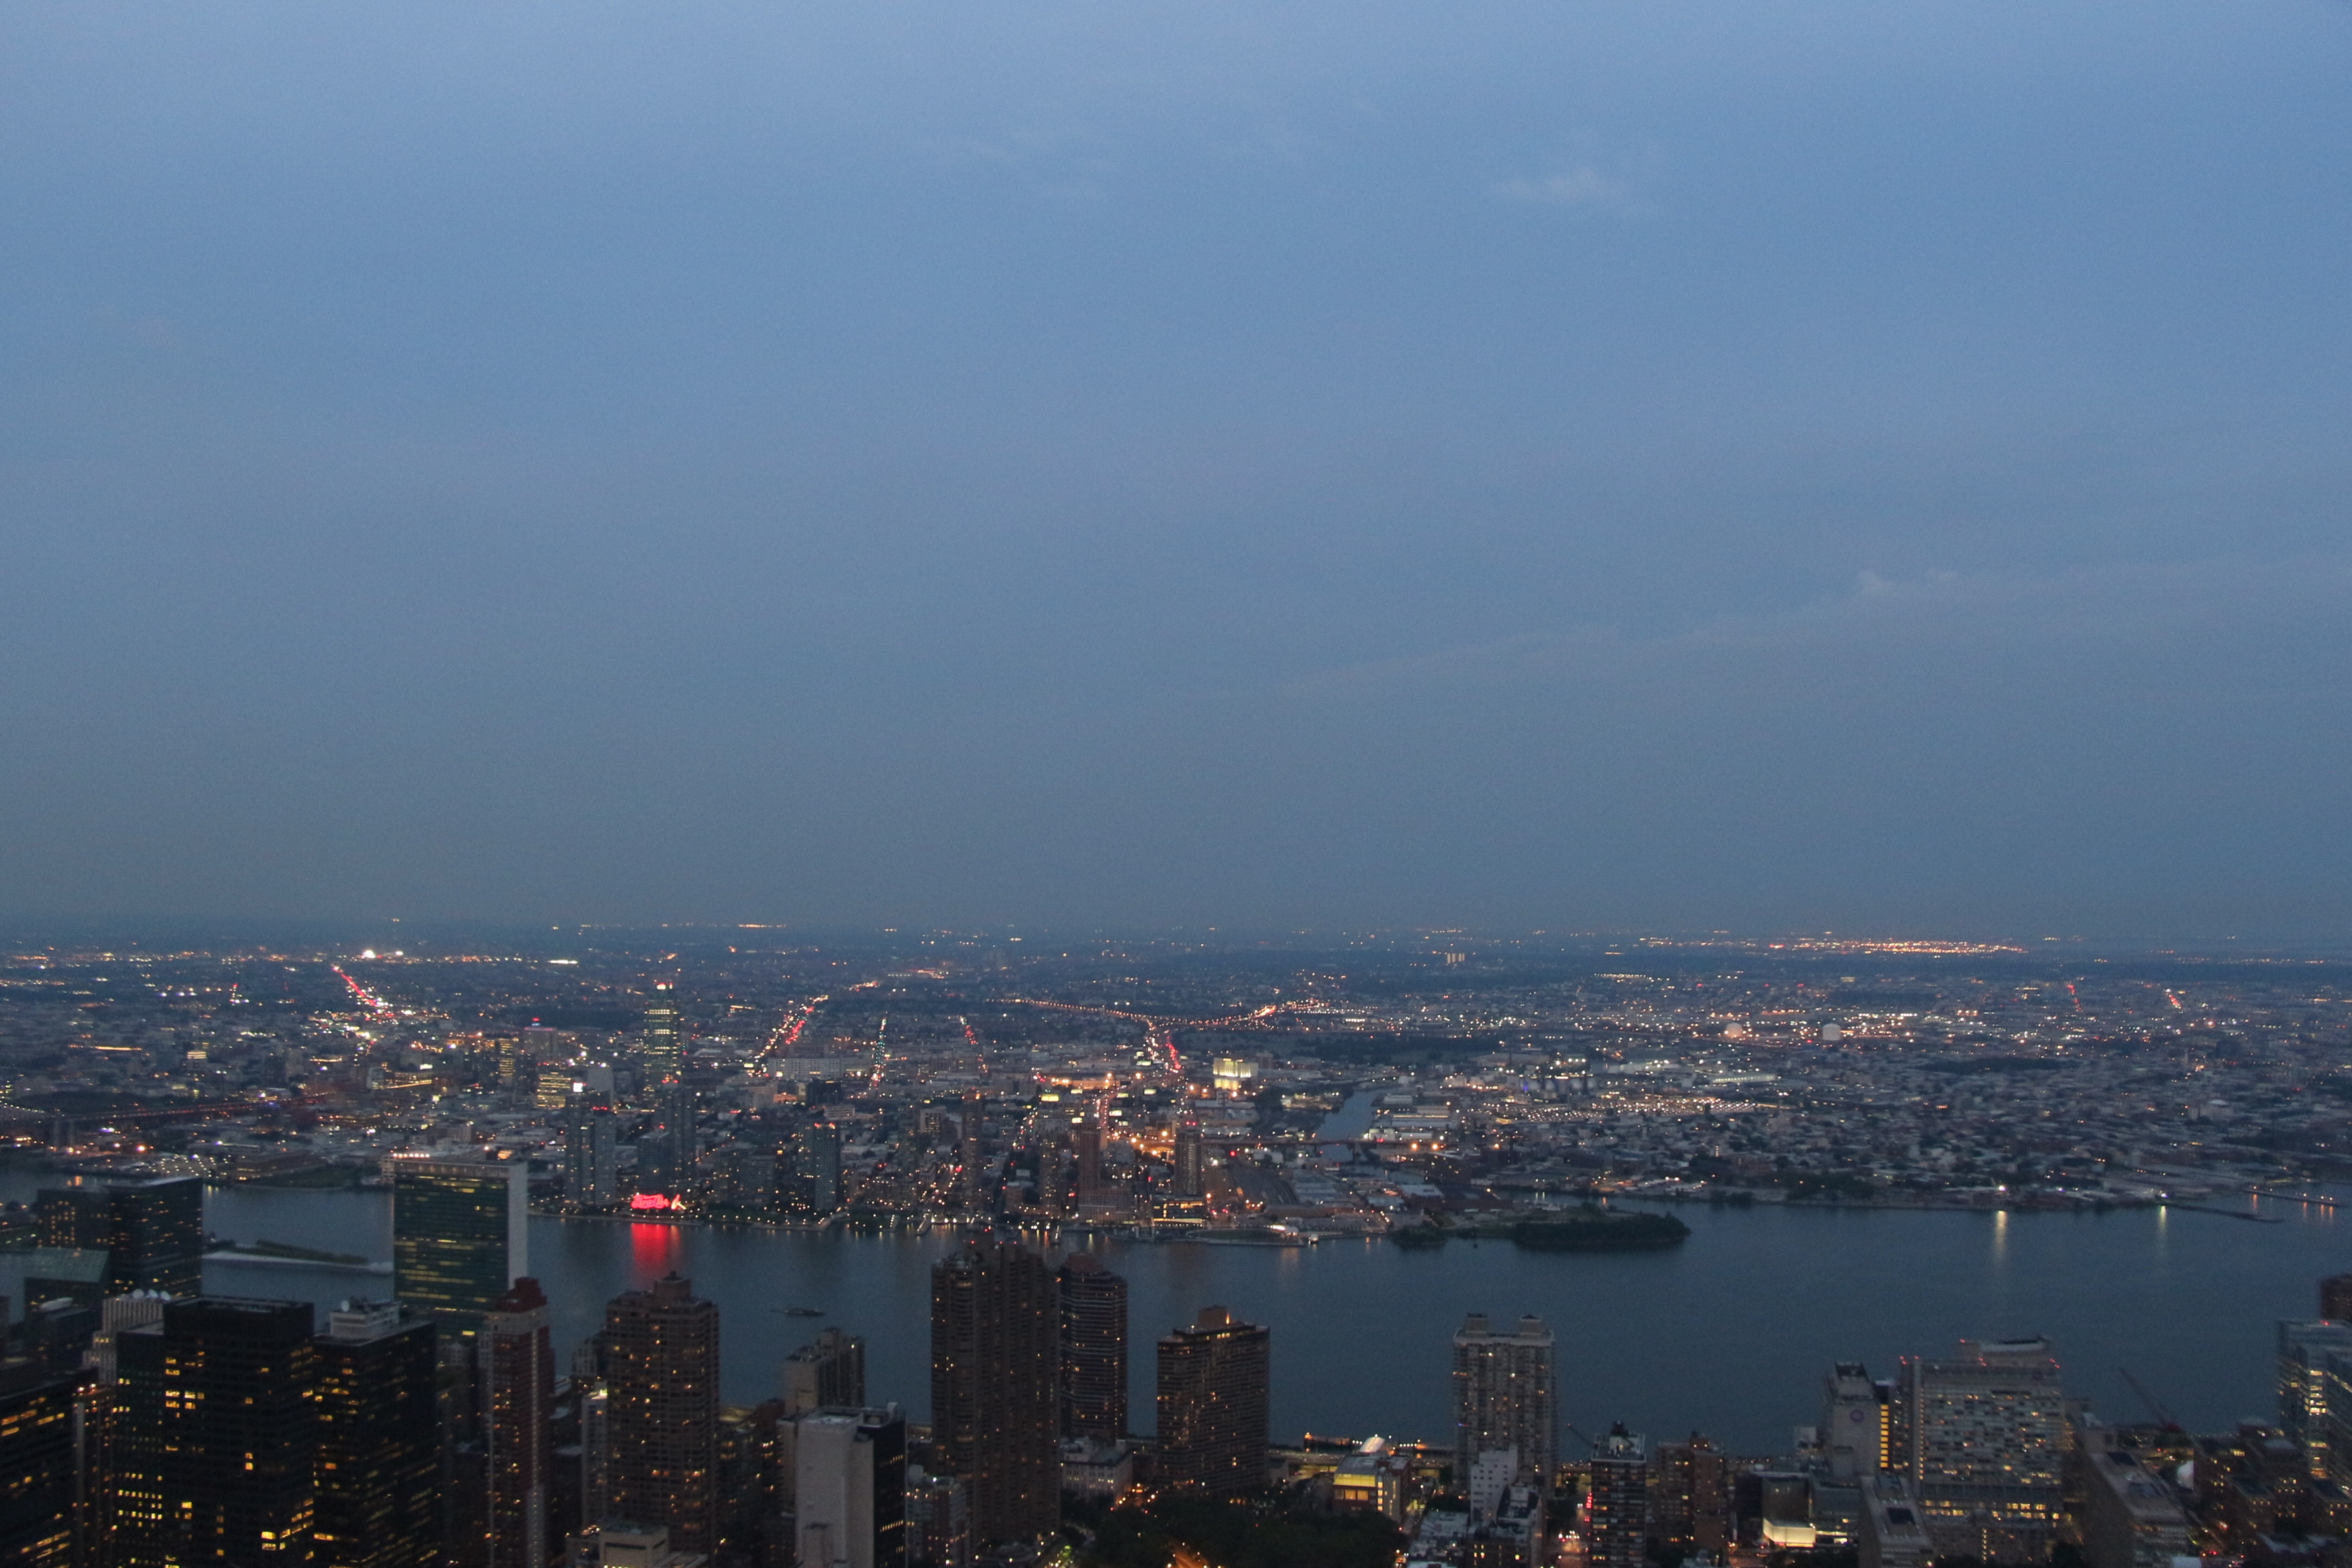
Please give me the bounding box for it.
[313,1303,440,1568]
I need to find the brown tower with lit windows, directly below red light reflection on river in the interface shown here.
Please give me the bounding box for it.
[602,1274,720,1552]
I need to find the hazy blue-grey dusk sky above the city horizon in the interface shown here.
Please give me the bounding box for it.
[0,0,2352,936]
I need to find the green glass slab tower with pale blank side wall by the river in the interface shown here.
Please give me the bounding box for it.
[391,1159,532,1328]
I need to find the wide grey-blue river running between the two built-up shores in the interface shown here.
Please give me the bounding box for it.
[0,1173,2352,1455]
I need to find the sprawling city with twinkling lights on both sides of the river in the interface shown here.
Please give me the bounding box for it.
[0,926,2352,1568]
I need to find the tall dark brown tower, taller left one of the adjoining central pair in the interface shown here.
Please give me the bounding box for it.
[932,1239,1061,1547]
